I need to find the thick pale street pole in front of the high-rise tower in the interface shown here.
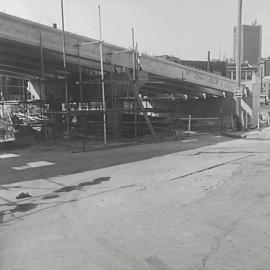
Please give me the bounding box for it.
[236,0,242,130]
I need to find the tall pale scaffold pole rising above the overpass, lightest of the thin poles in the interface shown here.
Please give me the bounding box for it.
[98,5,107,145]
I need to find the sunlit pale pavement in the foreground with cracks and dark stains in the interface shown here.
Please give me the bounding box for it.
[0,128,270,270]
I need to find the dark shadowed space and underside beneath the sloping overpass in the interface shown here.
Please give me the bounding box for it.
[0,29,234,143]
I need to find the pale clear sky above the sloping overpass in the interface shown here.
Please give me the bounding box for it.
[0,0,270,60]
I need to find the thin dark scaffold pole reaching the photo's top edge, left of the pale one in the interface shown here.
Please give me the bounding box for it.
[61,0,70,149]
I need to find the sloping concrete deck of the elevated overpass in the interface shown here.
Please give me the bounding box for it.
[0,13,236,96]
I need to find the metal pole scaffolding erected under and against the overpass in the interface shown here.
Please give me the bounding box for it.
[0,5,234,151]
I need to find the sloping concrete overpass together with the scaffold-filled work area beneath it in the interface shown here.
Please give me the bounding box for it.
[0,13,257,151]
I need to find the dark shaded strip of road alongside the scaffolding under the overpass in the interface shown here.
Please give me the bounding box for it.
[0,135,231,185]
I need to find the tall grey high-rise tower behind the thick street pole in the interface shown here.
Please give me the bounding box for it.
[233,22,262,65]
